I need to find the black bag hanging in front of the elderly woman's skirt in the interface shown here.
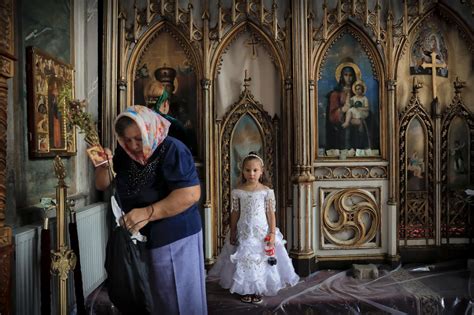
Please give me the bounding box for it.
[105,226,153,314]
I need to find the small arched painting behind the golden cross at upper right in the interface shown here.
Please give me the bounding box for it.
[410,22,448,78]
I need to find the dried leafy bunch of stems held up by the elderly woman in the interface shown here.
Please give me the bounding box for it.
[59,83,100,146]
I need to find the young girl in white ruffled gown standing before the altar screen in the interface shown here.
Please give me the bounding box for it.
[209,152,299,304]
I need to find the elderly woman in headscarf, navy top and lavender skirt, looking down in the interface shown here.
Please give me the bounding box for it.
[95,105,207,314]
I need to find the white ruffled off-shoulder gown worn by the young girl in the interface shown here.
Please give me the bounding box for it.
[208,189,299,296]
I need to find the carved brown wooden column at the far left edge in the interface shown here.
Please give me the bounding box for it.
[0,0,15,315]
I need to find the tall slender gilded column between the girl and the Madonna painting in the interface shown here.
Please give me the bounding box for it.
[290,0,315,275]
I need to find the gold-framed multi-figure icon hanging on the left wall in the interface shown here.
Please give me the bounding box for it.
[27,47,76,158]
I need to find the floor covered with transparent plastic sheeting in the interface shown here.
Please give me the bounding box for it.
[86,260,474,314]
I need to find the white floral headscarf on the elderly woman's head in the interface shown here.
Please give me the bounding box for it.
[114,105,170,165]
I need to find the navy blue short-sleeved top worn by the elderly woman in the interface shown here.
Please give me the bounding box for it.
[113,136,201,248]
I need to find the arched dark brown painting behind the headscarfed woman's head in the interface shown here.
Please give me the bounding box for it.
[133,28,199,155]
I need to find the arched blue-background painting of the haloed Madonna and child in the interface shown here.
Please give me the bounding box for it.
[317,31,381,160]
